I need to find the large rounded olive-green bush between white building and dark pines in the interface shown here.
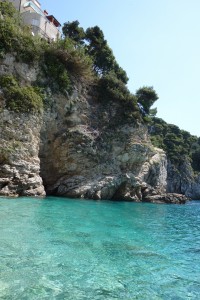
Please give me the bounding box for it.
[38,39,93,94]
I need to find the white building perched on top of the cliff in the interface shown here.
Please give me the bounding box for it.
[4,0,61,41]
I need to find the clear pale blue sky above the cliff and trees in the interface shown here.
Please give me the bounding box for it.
[40,0,200,136]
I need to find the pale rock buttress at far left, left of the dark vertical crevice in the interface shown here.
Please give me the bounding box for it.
[0,109,45,196]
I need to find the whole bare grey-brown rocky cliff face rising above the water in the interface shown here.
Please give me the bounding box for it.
[0,55,199,203]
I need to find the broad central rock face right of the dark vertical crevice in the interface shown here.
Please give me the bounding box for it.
[40,85,167,201]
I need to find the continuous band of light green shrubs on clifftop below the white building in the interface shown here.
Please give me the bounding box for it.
[0,2,92,93]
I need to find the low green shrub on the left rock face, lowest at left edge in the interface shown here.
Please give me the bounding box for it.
[0,75,43,113]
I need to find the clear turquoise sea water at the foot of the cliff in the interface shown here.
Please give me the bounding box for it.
[0,197,200,300]
